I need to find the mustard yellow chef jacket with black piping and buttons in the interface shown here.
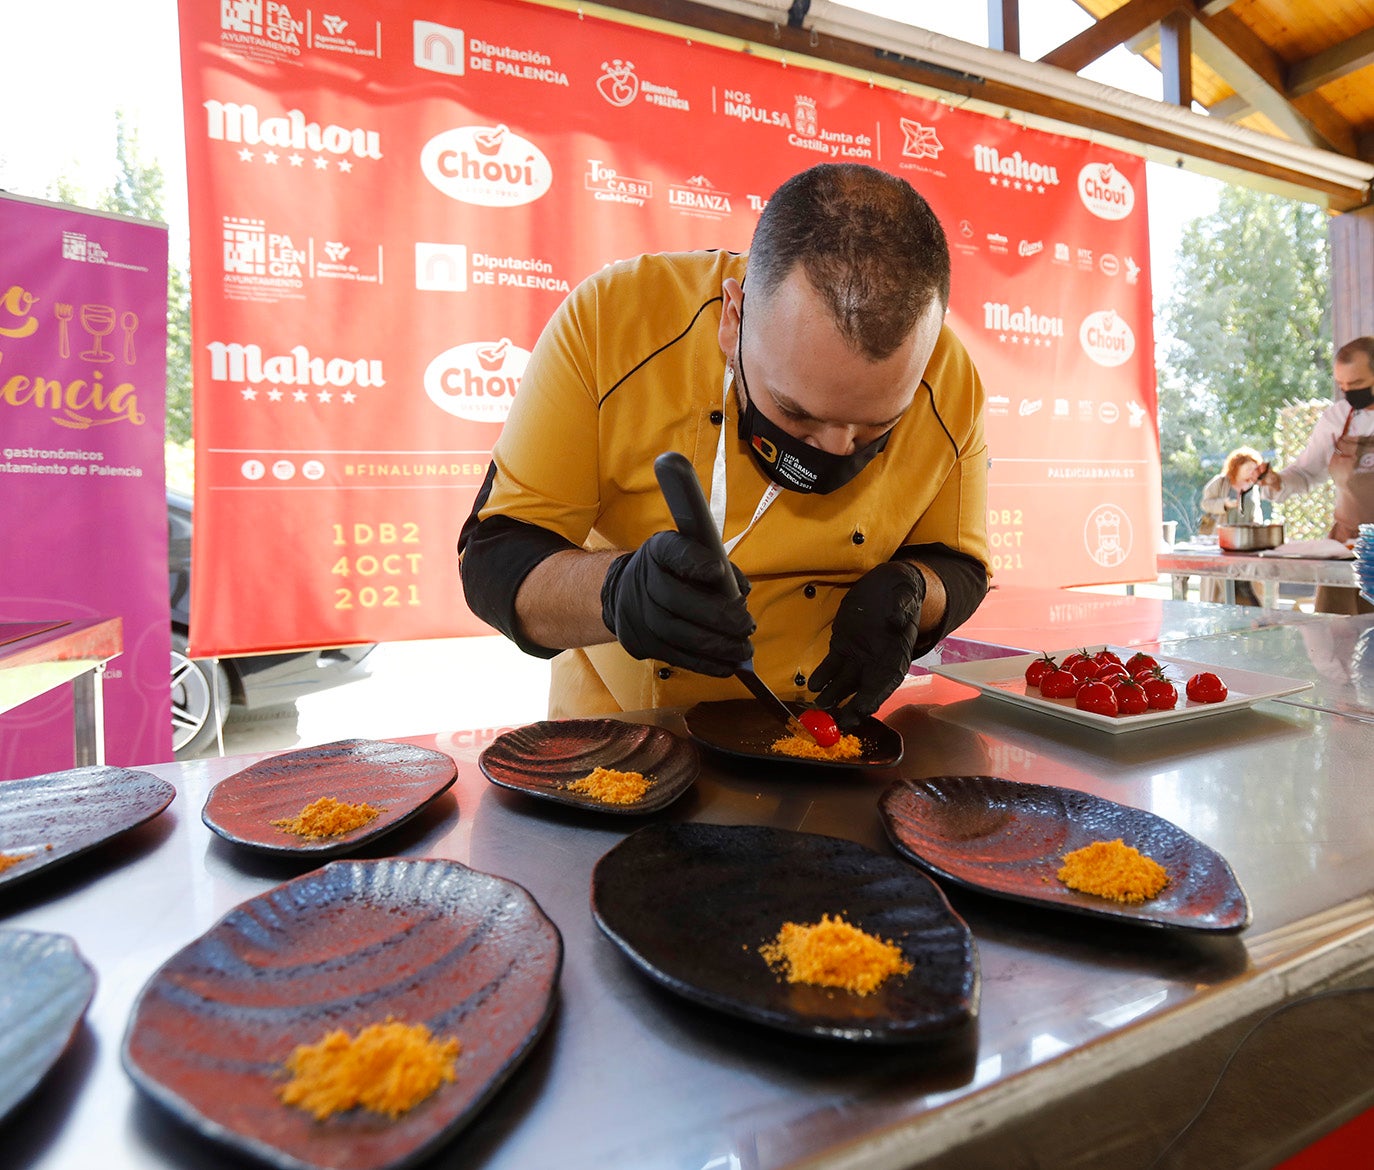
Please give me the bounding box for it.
[459,251,988,718]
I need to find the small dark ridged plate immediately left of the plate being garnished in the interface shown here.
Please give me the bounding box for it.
[477,720,701,816]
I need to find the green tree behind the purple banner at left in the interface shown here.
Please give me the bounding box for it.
[47,111,191,444]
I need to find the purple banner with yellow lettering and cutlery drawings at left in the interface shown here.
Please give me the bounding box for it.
[0,195,172,780]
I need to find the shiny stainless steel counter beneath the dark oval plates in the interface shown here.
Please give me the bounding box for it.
[0,590,1374,1170]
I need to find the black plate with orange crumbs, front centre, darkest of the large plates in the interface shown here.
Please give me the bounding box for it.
[592,824,978,1044]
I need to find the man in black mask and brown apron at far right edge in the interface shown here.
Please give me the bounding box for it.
[1260,338,1374,614]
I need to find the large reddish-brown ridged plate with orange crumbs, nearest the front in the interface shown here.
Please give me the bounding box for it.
[122,858,563,1170]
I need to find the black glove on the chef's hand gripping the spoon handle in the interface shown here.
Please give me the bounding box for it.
[602,531,754,678]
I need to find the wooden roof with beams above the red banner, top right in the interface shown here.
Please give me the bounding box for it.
[588,0,1374,211]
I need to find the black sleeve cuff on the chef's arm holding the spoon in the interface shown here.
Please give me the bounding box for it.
[458,508,577,658]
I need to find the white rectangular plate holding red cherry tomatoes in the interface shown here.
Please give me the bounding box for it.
[930,644,1312,735]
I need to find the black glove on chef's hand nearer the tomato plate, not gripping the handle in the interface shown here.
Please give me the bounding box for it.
[807,560,926,728]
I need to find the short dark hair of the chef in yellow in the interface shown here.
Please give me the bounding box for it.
[747,163,949,360]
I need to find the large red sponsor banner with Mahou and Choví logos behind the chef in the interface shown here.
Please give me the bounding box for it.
[181,0,1160,654]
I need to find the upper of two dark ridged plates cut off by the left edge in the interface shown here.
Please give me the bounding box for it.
[0,765,176,890]
